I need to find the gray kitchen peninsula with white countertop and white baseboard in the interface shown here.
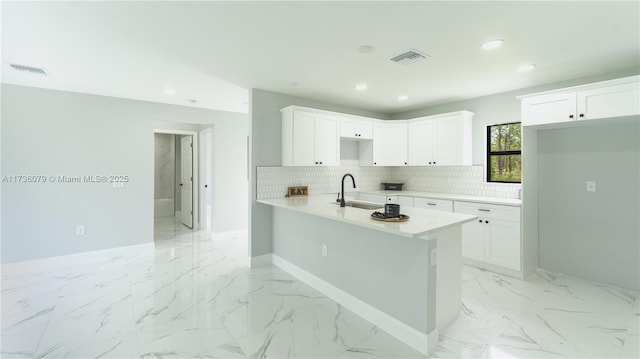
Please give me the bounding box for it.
[258,195,477,354]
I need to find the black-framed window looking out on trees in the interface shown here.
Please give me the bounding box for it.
[487,122,522,183]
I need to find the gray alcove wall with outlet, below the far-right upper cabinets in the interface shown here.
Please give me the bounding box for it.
[538,119,640,290]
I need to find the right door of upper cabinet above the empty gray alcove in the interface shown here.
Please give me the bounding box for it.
[577,82,640,120]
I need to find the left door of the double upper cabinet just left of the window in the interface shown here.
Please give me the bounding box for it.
[407,120,434,166]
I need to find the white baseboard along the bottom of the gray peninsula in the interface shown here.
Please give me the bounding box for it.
[270,254,439,355]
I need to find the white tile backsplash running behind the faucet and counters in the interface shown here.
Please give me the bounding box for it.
[256,165,521,199]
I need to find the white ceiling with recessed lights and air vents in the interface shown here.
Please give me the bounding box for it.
[1,1,640,113]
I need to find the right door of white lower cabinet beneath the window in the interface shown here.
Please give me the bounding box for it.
[484,219,520,271]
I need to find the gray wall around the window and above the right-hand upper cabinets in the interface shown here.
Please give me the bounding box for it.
[391,68,640,165]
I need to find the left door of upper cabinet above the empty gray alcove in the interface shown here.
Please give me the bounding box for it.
[522,92,576,126]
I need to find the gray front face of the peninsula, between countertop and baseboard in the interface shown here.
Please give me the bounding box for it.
[273,208,436,333]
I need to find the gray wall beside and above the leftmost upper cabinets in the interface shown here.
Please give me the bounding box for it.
[249,89,388,257]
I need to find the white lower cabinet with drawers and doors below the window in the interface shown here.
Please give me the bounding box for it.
[454,201,522,272]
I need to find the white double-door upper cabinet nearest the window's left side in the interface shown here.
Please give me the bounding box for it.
[408,111,473,166]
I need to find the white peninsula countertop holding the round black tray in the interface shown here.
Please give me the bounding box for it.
[257,194,478,238]
